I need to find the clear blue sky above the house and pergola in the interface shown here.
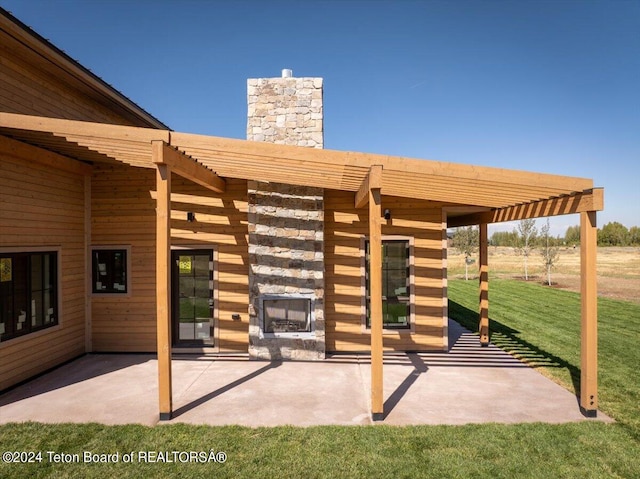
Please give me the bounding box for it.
[0,0,640,234]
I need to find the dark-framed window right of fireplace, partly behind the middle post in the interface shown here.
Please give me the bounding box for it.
[365,239,412,329]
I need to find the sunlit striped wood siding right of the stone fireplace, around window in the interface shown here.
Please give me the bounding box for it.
[325,190,446,351]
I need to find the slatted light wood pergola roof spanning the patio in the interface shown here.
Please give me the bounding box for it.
[0,113,593,212]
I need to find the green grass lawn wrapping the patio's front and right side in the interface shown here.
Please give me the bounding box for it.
[0,280,640,479]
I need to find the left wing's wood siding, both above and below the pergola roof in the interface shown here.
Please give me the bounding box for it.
[0,21,164,390]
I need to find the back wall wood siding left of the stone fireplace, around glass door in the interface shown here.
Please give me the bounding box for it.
[91,165,249,352]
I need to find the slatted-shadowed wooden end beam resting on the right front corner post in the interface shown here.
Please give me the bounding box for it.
[447,188,604,228]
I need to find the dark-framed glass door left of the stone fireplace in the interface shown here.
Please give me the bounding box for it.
[171,250,214,346]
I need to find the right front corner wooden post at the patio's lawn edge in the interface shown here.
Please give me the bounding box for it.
[580,211,598,417]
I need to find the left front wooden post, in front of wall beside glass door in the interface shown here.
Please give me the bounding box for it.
[152,141,173,421]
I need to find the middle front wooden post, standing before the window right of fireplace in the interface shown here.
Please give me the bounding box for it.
[368,165,384,421]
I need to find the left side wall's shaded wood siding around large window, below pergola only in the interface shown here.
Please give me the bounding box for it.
[0,137,86,390]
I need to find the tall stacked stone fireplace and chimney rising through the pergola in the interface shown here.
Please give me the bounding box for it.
[247,70,325,360]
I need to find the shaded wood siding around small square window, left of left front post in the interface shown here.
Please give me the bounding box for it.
[91,165,156,352]
